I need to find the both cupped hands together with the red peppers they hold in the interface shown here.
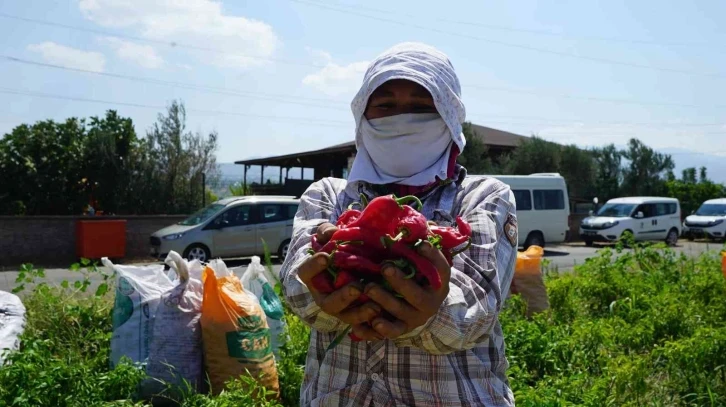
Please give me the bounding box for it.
[299,195,471,347]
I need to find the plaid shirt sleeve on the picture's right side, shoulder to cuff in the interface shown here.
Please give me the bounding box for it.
[395,178,517,354]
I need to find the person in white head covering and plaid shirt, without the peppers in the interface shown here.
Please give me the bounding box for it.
[281,43,517,407]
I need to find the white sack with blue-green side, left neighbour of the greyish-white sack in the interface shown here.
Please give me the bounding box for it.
[101,257,174,368]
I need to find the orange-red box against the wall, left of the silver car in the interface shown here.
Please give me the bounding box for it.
[76,220,126,259]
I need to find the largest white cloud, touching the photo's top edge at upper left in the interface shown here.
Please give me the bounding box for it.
[78,0,280,68]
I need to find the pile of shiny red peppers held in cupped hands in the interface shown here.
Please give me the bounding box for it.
[309,195,471,346]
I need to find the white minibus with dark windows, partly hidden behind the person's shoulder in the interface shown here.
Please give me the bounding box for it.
[491,174,570,249]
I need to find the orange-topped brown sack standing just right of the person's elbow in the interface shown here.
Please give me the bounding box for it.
[512,246,550,317]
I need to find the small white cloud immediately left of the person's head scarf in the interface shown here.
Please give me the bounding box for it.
[302,49,368,96]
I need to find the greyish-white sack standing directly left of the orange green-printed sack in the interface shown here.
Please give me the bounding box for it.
[146,251,204,393]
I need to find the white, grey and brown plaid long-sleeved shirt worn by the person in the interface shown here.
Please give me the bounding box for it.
[280,169,517,407]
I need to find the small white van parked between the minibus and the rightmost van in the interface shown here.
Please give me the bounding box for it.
[580,197,681,246]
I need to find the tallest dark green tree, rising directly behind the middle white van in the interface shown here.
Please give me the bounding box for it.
[621,139,675,196]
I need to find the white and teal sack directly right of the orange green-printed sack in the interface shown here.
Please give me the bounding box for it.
[240,256,287,359]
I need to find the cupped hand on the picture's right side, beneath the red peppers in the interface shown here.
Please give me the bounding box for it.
[362,242,451,339]
